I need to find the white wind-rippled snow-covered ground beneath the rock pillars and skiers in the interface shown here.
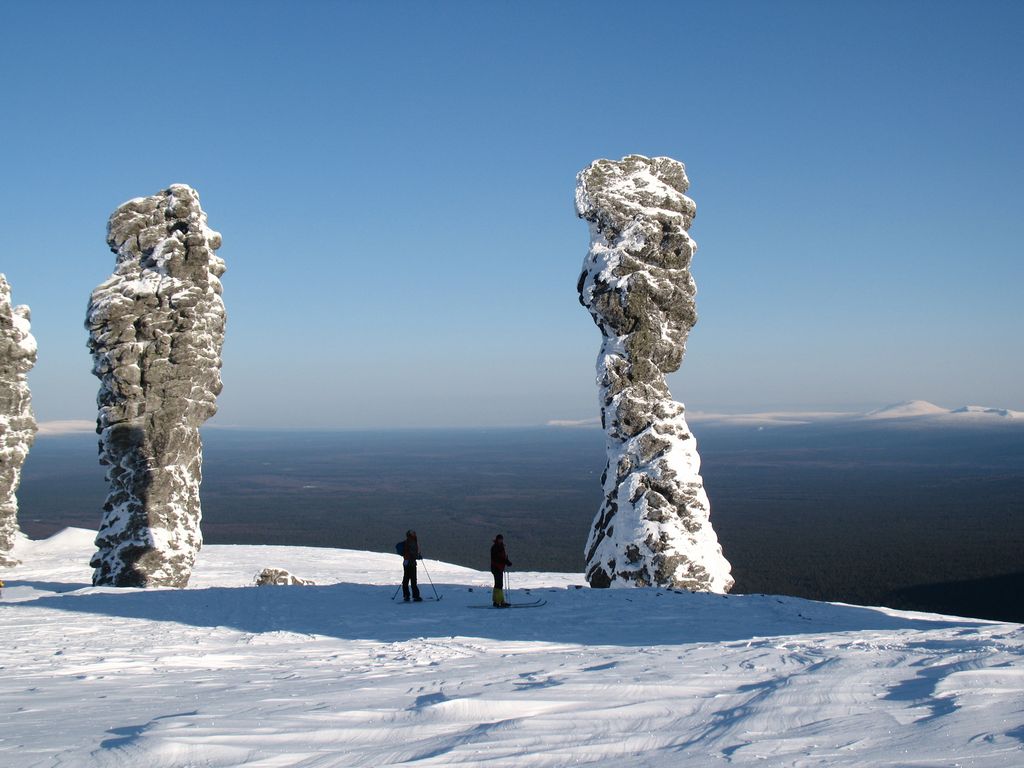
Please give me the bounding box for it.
[6,529,1024,768]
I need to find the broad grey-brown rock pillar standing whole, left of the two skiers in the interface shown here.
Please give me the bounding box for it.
[86,184,225,587]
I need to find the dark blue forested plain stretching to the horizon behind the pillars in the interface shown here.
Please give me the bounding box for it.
[18,422,1024,622]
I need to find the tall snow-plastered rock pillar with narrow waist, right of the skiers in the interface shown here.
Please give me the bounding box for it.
[575,155,733,592]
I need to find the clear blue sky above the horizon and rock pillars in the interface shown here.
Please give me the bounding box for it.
[0,1,1024,427]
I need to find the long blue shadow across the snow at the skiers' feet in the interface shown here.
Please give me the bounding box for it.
[7,584,985,647]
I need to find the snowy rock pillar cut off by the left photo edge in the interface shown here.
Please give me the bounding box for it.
[0,274,36,565]
